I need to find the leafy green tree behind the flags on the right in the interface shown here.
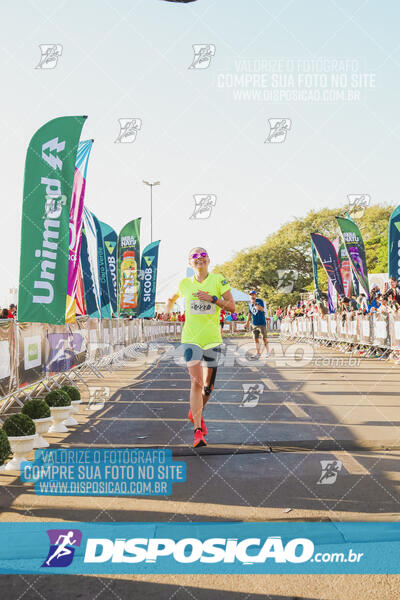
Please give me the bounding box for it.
[214,205,394,309]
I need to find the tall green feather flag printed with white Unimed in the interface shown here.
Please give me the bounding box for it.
[18,117,86,325]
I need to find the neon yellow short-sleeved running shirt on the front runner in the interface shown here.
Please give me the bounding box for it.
[177,273,231,350]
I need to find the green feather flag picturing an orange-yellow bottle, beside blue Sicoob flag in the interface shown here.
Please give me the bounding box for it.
[117,217,141,316]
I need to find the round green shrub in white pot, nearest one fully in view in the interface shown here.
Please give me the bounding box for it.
[3,413,36,471]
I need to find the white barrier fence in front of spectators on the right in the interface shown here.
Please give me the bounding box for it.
[281,313,400,356]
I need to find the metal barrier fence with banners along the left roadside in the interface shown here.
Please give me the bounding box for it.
[0,317,182,414]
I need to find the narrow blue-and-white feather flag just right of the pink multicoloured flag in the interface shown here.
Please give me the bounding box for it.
[81,207,101,318]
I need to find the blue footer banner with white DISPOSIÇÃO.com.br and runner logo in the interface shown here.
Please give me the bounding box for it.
[0,522,400,575]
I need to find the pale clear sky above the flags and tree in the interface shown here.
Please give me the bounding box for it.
[0,0,400,300]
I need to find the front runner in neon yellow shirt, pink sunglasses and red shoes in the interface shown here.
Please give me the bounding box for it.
[167,246,235,448]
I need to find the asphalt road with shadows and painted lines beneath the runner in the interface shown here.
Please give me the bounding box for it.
[0,338,400,600]
